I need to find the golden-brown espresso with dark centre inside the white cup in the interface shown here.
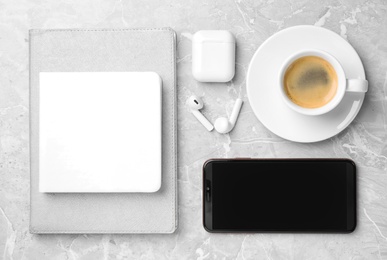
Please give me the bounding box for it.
[283,56,338,108]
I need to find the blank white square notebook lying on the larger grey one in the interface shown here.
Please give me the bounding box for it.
[39,72,162,192]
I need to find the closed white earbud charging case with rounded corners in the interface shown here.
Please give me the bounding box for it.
[192,30,235,82]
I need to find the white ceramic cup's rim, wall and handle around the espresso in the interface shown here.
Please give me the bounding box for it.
[278,49,368,116]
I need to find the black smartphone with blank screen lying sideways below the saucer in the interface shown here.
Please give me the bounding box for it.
[203,159,356,233]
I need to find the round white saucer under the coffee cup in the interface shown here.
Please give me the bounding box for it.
[247,25,365,143]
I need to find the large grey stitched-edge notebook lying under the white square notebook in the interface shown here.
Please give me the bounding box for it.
[30,28,178,233]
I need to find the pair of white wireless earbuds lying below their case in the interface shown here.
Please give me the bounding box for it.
[187,96,243,134]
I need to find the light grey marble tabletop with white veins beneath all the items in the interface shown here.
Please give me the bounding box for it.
[0,0,387,259]
